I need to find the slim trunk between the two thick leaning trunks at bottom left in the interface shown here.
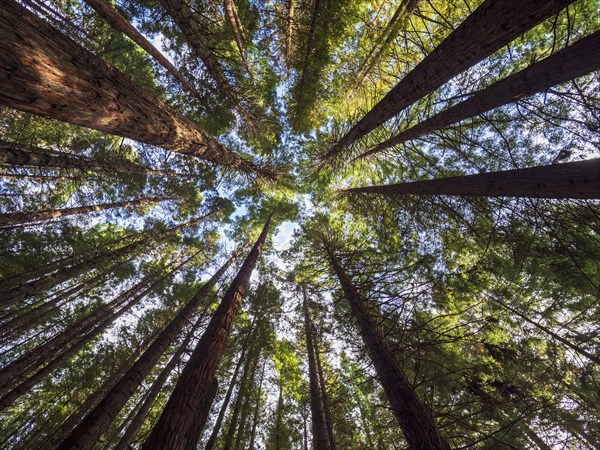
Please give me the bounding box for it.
[115,315,204,450]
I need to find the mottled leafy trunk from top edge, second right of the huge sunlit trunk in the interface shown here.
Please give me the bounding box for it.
[161,0,257,134]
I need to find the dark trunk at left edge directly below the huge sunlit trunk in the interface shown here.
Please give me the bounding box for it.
[0,141,169,176]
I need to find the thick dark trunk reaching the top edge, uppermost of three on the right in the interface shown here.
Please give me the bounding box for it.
[324,0,575,160]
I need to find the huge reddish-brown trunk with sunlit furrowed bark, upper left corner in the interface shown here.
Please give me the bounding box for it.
[0,0,265,175]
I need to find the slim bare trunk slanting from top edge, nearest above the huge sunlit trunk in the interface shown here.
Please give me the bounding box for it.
[85,0,205,103]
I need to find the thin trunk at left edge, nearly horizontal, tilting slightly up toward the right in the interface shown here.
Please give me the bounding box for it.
[0,197,168,228]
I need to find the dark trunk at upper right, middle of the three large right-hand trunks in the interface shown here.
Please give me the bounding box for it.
[356,31,600,159]
